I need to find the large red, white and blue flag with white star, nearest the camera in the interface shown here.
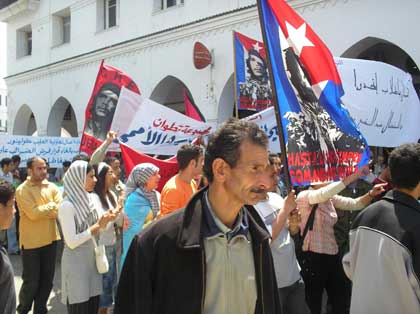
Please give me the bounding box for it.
[258,0,370,186]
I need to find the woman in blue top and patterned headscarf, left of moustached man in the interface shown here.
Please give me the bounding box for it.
[120,163,160,268]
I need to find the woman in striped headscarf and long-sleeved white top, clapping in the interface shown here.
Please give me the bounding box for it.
[58,160,116,314]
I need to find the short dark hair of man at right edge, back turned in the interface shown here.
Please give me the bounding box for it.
[388,144,420,190]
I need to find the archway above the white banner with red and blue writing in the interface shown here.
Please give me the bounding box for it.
[150,75,192,114]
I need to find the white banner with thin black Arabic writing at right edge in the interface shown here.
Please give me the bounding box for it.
[335,58,420,147]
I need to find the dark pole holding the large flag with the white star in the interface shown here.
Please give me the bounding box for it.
[257,0,292,191]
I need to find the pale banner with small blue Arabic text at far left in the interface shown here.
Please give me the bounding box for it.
[0,135,80,168]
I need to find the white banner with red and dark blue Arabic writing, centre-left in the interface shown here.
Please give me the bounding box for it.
[111,88,215,155]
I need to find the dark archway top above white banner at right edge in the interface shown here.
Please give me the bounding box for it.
[342,37,420,97]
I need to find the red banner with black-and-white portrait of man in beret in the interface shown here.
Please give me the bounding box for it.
[80,61,140,155]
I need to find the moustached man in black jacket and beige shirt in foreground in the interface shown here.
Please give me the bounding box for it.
[114,119,281,314]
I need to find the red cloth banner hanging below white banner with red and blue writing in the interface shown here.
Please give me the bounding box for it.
[120,143,178,192]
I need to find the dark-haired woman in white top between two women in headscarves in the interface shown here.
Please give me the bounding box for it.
[92,162,123,314]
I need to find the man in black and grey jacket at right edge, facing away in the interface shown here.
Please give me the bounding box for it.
[343,144,420,314]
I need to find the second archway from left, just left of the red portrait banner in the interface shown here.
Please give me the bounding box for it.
[47,97,77,137]
